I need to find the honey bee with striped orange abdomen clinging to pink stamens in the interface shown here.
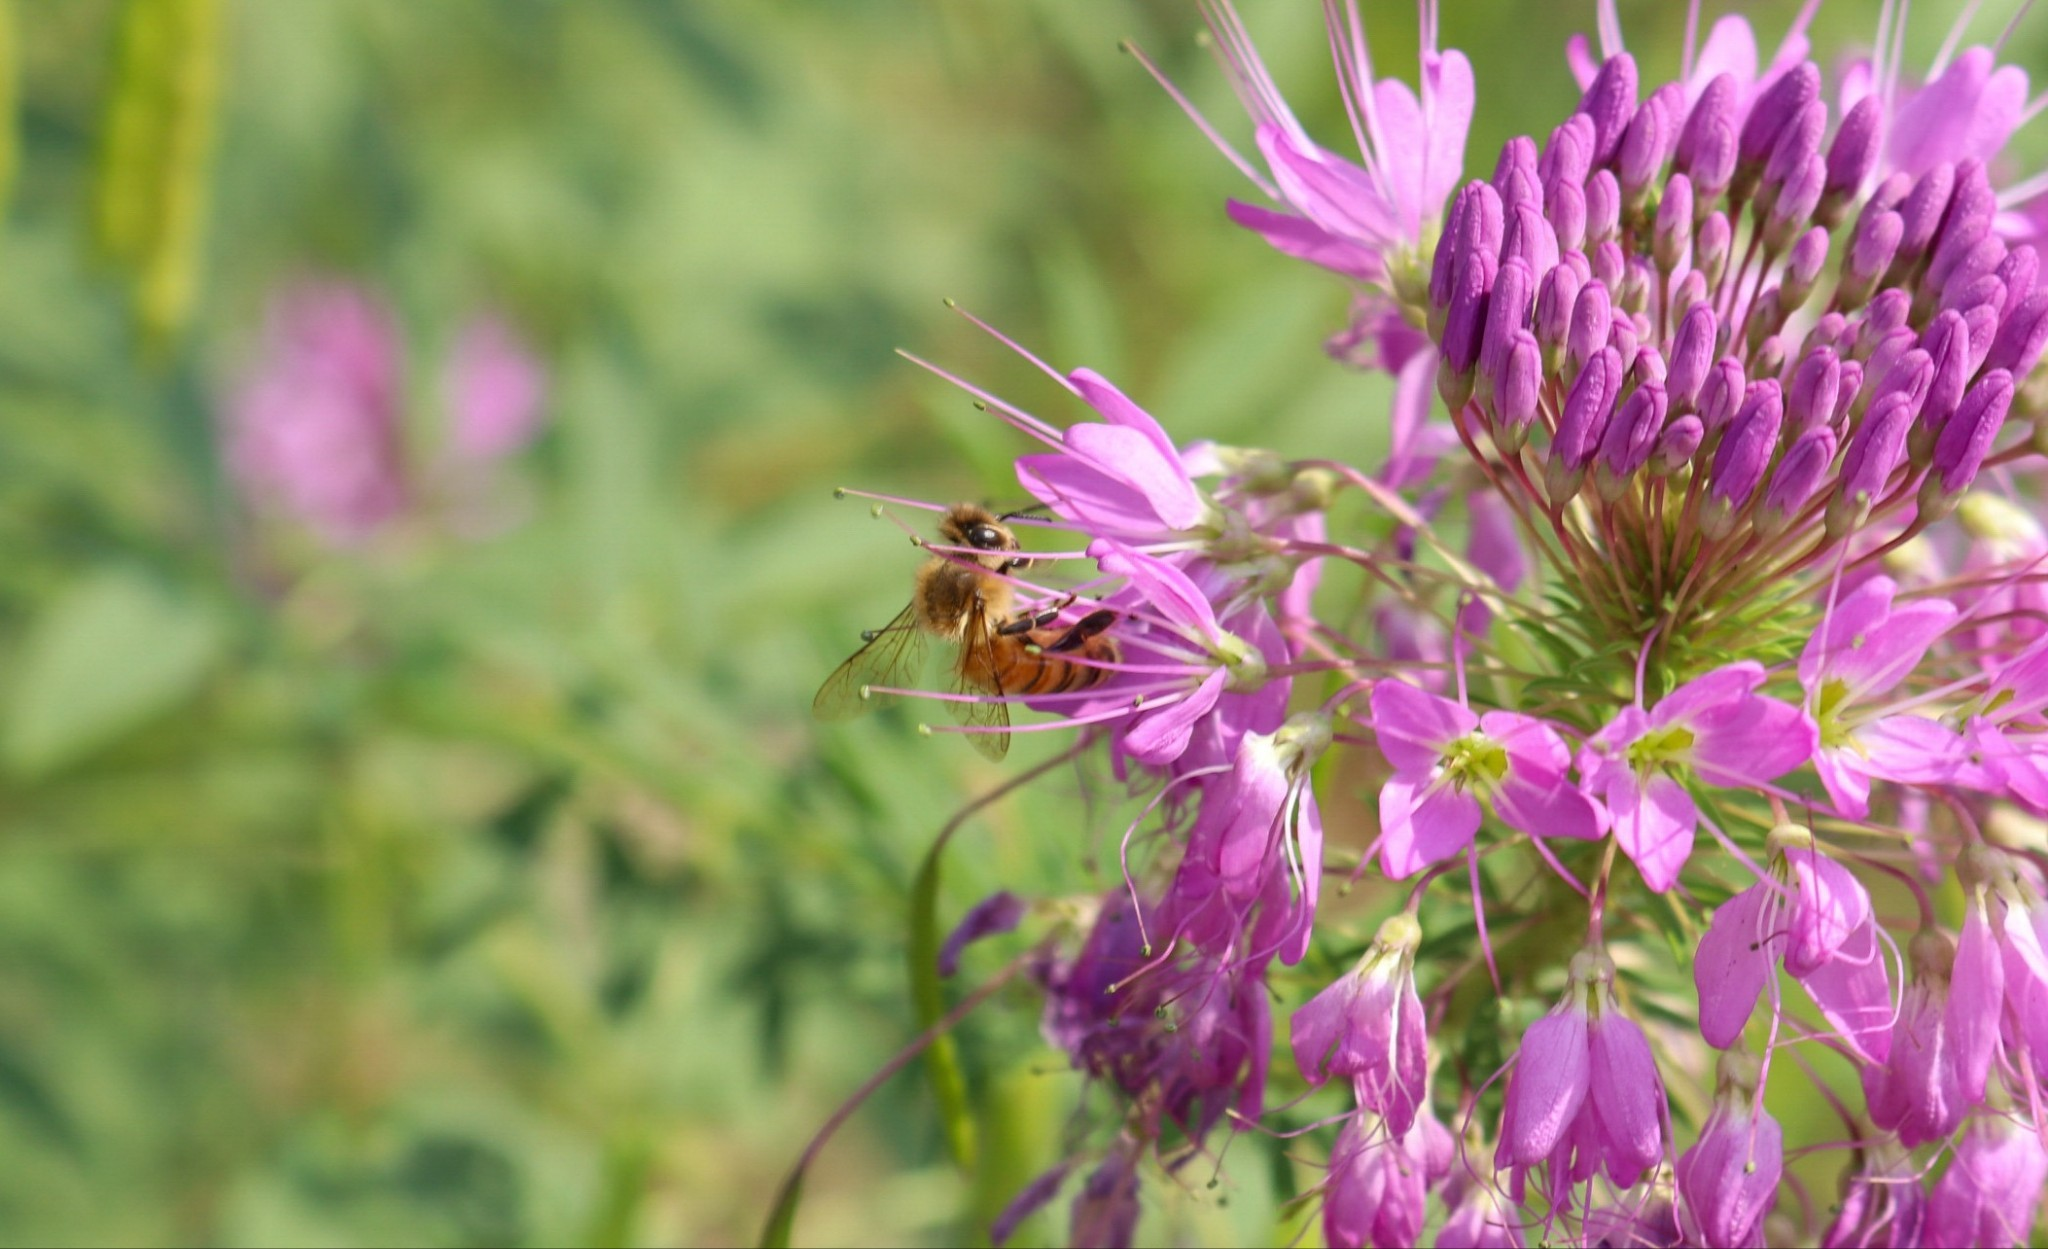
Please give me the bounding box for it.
[811,504,1118,760]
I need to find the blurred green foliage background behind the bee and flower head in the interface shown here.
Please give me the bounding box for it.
[0,0,2044,1245]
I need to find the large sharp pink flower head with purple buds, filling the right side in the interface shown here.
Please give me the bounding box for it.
[831,0,2048,1247]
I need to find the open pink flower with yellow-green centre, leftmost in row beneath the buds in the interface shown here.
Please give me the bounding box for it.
[1372,680,1602,880]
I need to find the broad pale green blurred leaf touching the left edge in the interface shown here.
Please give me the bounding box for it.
[0,569,225,776]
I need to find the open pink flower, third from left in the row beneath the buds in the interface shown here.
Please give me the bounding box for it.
[1798,577,1962,819]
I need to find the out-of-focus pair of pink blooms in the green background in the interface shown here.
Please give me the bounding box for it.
[221,281,547,547]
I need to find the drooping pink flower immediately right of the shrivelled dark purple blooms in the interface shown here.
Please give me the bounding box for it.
[1288,911,1430,1136]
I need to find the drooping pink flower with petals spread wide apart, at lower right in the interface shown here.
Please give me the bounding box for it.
[1692,825,1892,1063]
